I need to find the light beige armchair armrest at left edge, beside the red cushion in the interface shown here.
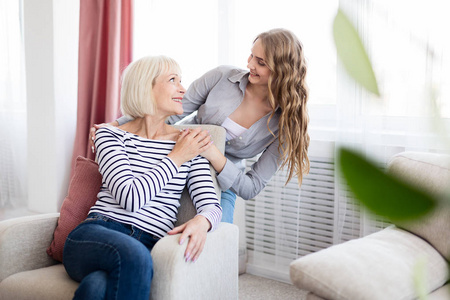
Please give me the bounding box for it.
[0,213,59,281]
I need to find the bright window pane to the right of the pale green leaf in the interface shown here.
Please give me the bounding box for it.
[361,0,450,118]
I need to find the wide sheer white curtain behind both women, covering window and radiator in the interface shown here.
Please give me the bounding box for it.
[134,0,450,282]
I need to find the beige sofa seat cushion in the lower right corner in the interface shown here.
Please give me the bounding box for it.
[290,226,448,299]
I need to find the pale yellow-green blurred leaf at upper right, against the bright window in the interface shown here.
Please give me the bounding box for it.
[333,10,380,96]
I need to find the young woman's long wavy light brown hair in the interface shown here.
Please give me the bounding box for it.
[254,29,310,185]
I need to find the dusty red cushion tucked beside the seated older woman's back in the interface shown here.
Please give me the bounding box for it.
[47,156,102,262]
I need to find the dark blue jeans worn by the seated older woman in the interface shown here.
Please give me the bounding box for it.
[63,213,159,300]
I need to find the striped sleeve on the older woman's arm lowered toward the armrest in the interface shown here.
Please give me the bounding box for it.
[187,156,222,231]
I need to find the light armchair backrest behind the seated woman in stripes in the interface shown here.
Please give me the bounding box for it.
[175,125,225,226]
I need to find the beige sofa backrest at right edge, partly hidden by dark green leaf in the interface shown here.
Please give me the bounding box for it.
[388,152,450,260]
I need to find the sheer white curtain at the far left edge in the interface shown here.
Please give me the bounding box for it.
[0,0,27,208]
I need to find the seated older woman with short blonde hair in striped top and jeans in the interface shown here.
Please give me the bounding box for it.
[63,56,222,300]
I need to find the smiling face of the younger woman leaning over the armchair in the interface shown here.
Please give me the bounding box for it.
[247,39,270,85]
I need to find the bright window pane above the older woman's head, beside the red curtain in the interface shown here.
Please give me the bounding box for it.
[133,0,219,88]
